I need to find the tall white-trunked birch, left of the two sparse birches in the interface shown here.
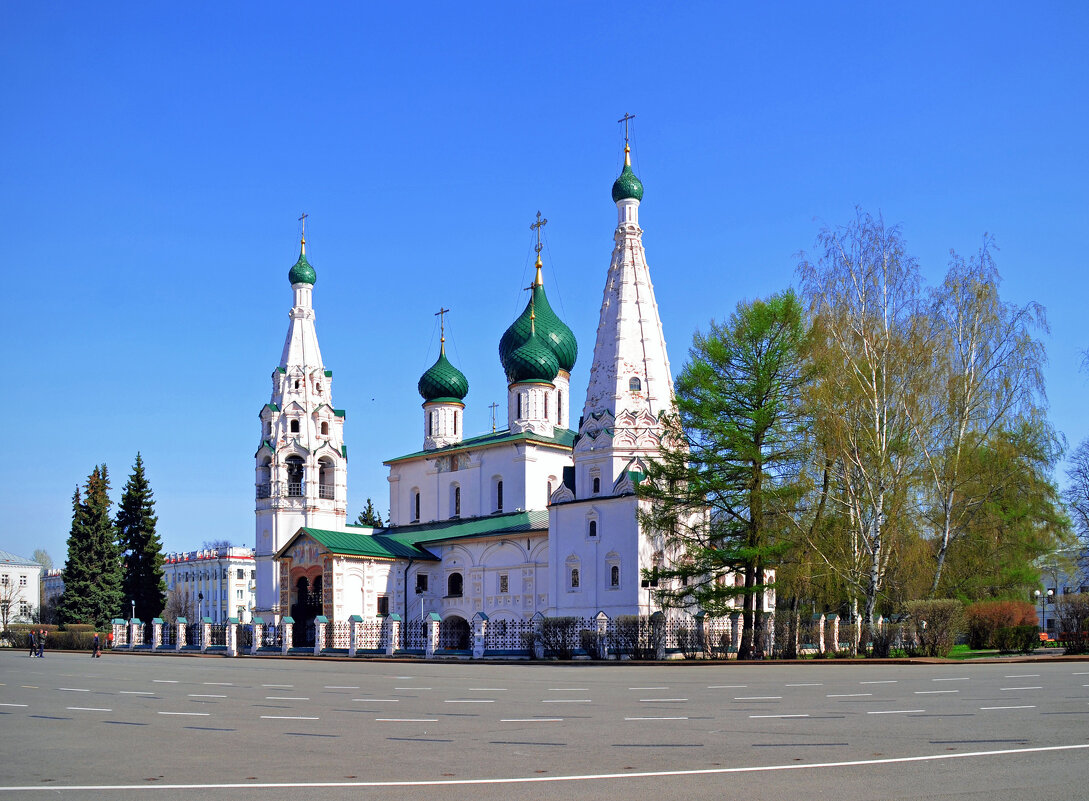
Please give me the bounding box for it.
[798,210,926,636]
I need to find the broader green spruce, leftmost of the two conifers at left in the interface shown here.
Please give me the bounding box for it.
[58,465,122,628]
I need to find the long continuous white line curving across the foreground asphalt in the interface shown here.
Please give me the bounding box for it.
[23,740,1089,792]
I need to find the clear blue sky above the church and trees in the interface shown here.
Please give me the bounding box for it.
[0,2,1089,565]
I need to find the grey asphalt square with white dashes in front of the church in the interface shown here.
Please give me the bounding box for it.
[0,651,1089,801]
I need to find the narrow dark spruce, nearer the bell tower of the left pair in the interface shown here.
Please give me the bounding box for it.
[117,453,167,620]
